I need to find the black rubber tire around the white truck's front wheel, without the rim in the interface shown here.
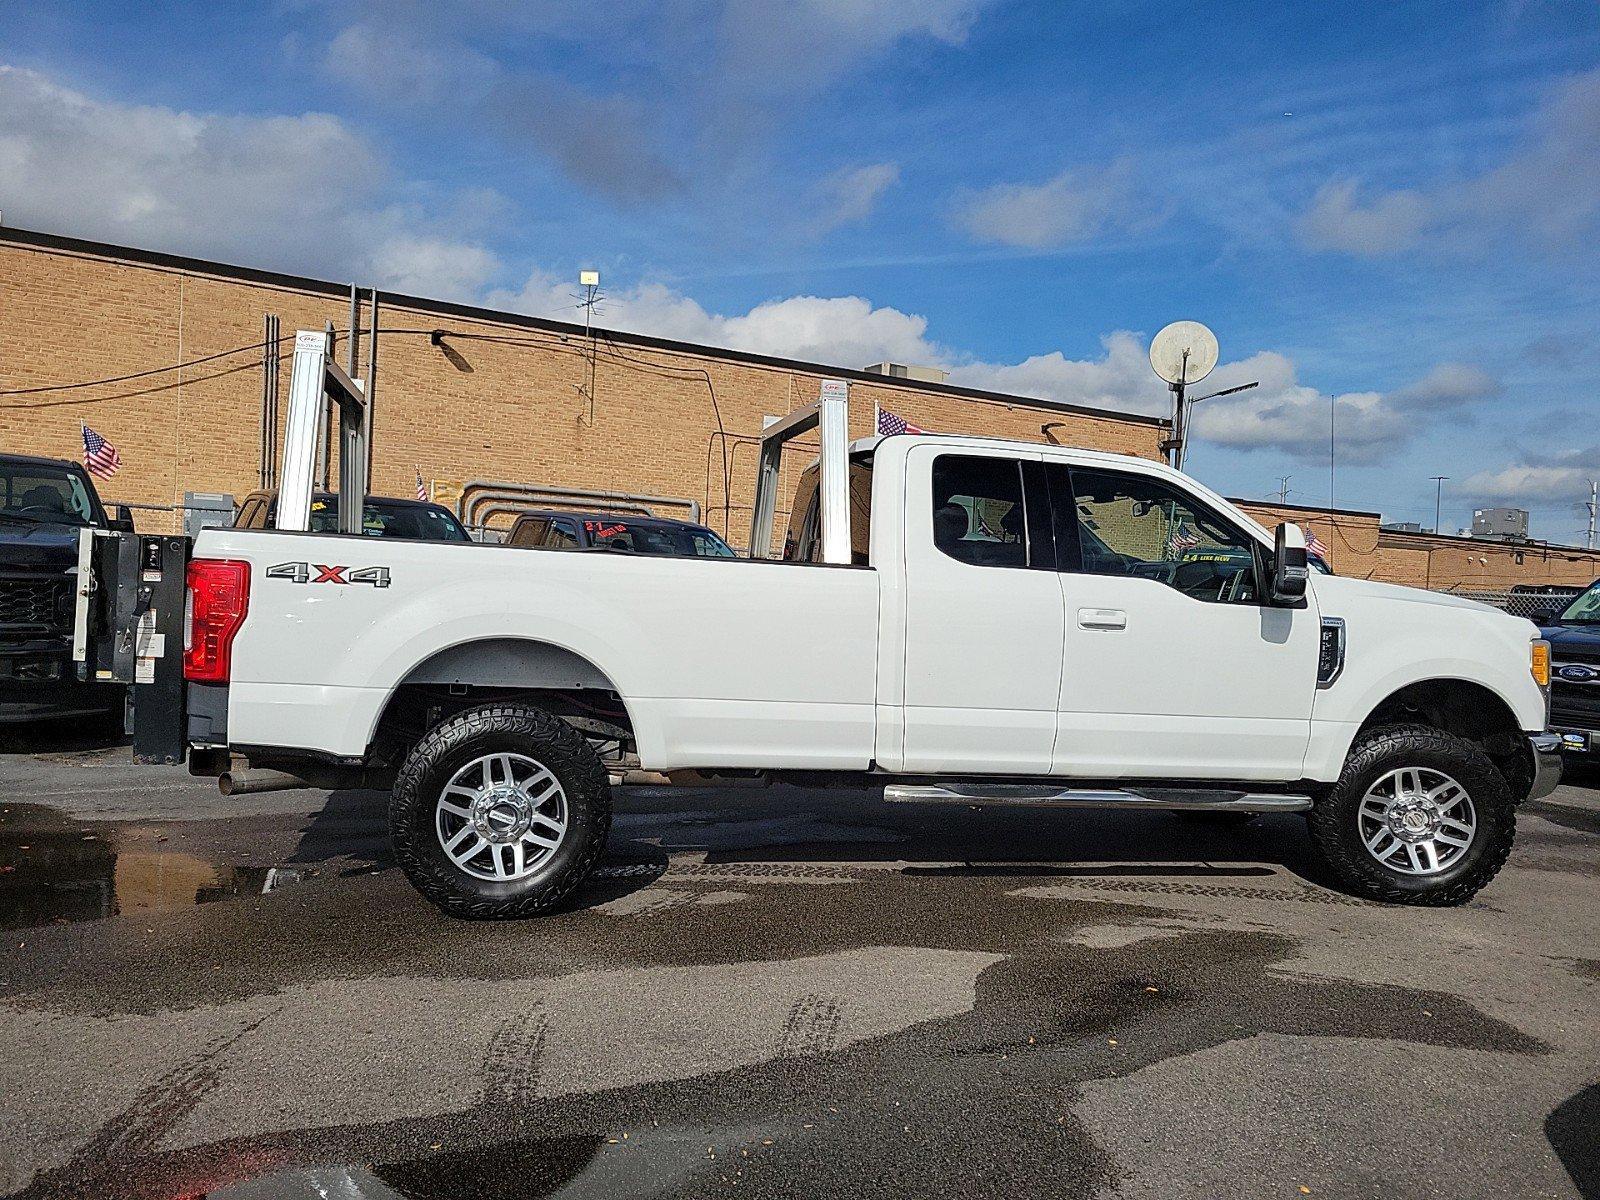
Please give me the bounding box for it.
[1306,725,1517,907]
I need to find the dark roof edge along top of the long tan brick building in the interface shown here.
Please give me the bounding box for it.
[0,227,1166,426]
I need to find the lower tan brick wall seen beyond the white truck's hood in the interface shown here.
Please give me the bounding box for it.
[1240,502,1600,592]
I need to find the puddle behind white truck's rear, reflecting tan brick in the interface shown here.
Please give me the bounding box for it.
[0,805,317,930]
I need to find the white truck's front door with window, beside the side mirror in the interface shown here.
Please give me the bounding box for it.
[1046,462,1320,779]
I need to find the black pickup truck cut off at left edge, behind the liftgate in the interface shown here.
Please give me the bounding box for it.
[0,454,133,725]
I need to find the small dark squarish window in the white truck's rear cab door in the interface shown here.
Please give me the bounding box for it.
[933,454,1027,566]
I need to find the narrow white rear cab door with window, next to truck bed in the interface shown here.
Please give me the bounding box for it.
[904,446,1062,774]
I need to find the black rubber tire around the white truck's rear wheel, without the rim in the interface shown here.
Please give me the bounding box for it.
[389,704,611,920]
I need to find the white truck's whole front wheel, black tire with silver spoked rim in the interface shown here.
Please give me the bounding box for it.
[1307,725,1517,906]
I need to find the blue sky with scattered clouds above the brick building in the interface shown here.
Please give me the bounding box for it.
[9,0,1600,542]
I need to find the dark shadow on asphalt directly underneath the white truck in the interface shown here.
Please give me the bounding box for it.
[286,786,1330,909]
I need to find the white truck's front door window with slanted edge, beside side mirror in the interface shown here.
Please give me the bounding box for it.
[1072,467,1256,603]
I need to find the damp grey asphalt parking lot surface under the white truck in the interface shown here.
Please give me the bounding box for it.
[0,738,1600,1200]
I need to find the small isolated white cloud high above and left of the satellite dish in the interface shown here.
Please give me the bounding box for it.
[957,160,1162,250]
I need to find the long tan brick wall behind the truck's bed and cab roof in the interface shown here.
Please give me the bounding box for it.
[0,242,1160,544]
